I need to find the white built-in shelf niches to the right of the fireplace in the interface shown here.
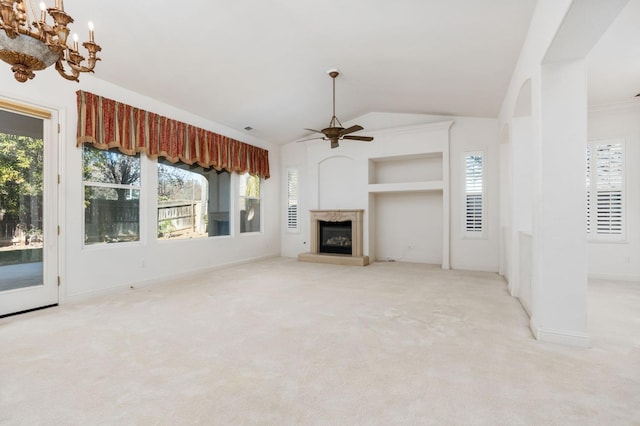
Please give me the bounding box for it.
[367,121,453,269]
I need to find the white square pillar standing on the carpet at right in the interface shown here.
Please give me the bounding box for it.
[531,59,589,346]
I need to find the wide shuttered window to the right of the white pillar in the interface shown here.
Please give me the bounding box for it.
[587,141,625,240]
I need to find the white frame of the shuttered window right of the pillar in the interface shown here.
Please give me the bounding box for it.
[585,138,628,243]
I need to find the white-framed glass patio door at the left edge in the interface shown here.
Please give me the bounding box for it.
[0,100,58,316]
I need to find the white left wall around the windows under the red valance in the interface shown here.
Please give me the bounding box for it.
[0,71,280,302]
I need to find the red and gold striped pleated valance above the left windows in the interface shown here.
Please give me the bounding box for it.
[77,90,270,179]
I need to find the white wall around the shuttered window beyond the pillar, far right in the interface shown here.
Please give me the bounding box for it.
[587,102,640,281]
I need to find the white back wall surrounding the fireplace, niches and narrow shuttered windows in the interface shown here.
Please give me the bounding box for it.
[281,113,499,271]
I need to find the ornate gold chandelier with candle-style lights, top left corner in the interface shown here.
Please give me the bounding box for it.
[0,0,102,83]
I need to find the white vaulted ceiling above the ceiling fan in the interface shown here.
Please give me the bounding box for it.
[58,0,640,144]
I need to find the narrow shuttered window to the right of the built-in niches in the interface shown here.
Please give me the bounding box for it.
[464,152,485,237]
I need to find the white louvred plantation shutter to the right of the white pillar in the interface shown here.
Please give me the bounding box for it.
[595,143,623,235]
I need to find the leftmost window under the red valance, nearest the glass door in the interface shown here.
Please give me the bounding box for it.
[82,145,140,245]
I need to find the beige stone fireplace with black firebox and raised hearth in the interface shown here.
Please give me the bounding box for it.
[298,210,369,266]
